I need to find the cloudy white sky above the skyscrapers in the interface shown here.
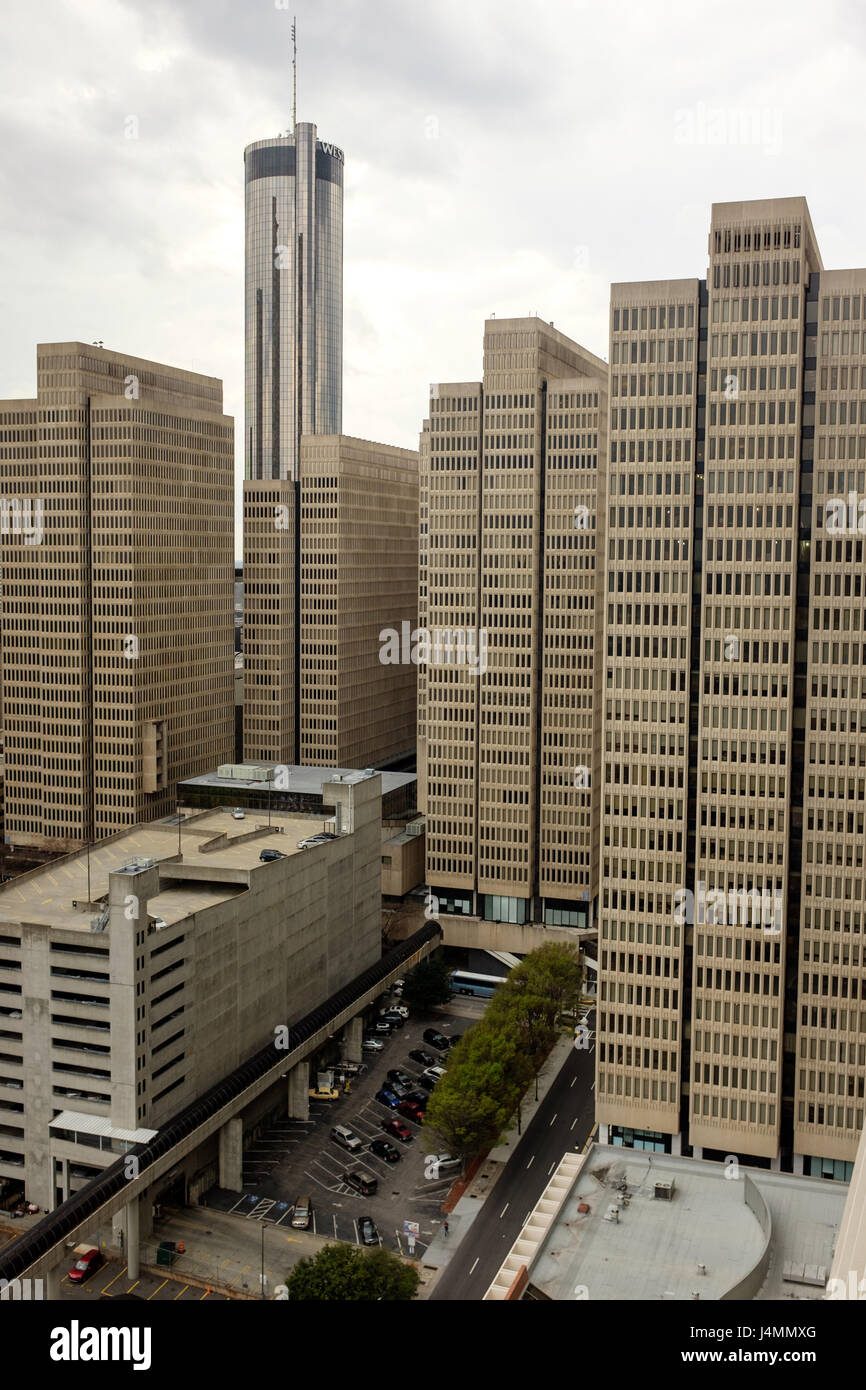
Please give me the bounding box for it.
[0,0,866,553]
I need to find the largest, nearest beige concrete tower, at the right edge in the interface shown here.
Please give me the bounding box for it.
[596,199,866,1177]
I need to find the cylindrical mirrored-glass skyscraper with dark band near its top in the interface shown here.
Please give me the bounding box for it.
[243,122,343,481]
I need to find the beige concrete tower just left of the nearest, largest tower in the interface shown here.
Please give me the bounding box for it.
[418,318,607,944]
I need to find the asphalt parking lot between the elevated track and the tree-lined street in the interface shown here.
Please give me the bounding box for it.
[207,1001,484,1259]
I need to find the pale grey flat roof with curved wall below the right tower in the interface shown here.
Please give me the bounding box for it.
[530,1145,848,1302]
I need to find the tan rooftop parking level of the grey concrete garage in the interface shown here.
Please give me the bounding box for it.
[0,806,350,933]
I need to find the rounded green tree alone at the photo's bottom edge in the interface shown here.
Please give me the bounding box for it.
[286,1245,420,1302]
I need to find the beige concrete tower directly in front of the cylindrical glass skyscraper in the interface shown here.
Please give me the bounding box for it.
[243,435,418,767]
